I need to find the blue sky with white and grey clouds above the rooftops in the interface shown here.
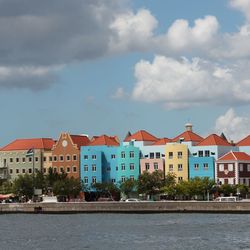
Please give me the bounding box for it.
[0,0,250,146]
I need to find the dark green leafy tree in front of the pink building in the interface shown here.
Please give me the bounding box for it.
[138,170,164,196]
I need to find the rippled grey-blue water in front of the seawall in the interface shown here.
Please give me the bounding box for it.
[0,214,250,250]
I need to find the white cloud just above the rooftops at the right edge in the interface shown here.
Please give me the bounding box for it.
[214,108,250,142]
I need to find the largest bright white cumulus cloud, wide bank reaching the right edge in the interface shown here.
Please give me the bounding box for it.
[132,56,250,109]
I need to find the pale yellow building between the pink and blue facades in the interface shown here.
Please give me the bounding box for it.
[165,143,188,182]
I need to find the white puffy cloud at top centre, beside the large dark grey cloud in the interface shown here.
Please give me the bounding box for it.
[109,9,158,52]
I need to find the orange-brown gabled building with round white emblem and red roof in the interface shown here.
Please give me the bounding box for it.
[52,133,90,179]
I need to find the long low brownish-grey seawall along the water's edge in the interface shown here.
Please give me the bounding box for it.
[0,201,250,214]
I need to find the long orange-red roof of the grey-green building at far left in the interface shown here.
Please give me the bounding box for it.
[1,138,55,151]
